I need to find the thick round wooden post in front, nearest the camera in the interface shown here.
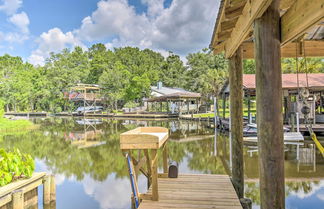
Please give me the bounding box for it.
[254,0,285,209]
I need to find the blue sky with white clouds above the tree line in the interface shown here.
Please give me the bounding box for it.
[0,0,219,64]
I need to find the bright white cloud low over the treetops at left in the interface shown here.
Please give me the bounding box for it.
[28,28,83,65]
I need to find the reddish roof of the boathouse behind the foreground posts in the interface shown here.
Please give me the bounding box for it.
[243,73,324,89]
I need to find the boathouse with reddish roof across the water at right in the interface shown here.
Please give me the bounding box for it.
[220,73,324,123]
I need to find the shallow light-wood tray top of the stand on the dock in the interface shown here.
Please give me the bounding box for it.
[120,127,169,150]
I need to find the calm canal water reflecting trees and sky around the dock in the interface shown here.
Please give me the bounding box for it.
[0,118,324,209]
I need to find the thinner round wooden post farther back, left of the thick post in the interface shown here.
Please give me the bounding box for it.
[229,47,244,198]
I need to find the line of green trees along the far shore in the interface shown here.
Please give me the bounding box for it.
[0,43,324,112]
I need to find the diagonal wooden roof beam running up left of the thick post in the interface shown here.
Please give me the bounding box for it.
[225,0,272,58]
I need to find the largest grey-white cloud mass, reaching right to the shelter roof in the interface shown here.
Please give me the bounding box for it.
[75,0,218,54]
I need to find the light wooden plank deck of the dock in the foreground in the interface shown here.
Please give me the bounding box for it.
[139,174,242,209]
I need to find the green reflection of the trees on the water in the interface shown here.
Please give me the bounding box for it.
[0,118,225,181]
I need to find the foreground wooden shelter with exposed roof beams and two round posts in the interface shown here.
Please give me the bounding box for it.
[210,0,324,209]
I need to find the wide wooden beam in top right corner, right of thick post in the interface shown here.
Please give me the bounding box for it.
[280,0,324,45]
